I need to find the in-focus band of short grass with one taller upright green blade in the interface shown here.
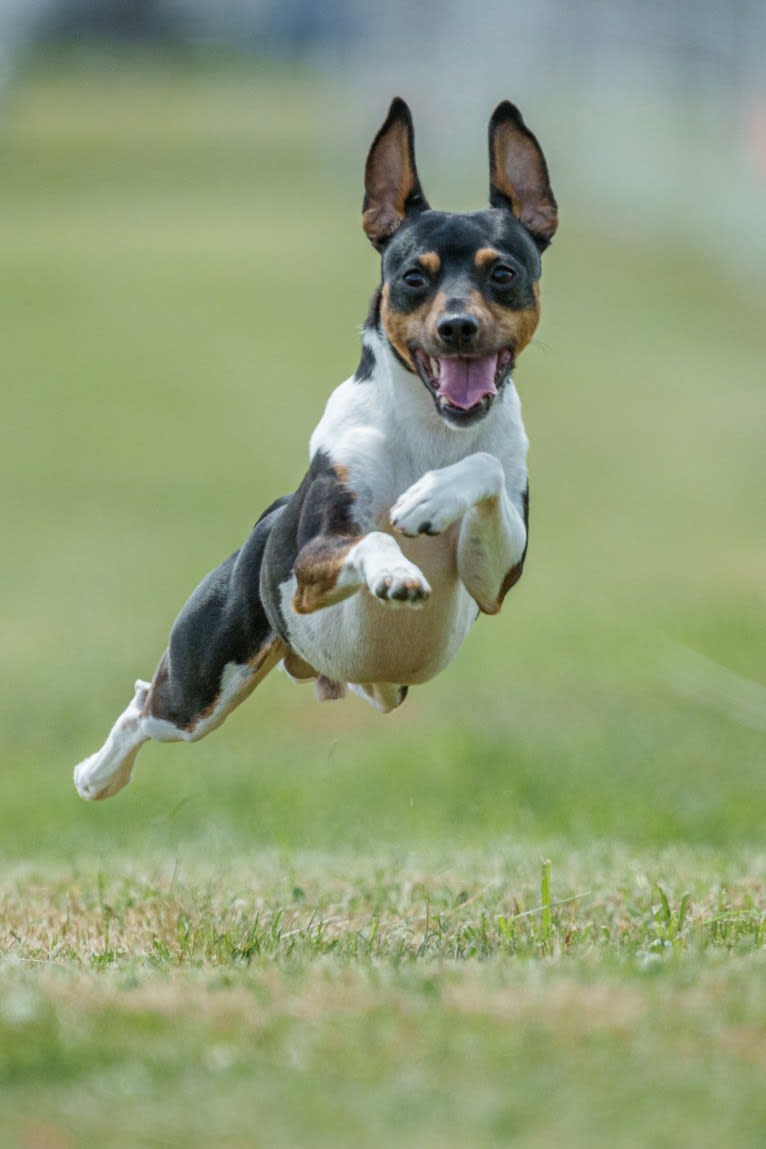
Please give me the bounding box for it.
[0,862,766,970]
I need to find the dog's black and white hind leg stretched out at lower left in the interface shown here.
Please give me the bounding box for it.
[75,501,288,800]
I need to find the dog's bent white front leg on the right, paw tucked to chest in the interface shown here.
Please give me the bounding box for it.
[390,452,527,615]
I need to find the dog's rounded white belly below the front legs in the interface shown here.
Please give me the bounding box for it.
[280,539,478,686]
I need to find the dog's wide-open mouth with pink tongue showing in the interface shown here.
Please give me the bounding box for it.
[413,348,512,424]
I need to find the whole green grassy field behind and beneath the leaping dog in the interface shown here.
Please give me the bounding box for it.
[0,54,766,1149]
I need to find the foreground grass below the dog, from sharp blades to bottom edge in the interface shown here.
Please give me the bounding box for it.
[0,847,766,1147]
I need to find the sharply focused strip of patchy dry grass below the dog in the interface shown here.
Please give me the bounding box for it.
[0,851,766,971]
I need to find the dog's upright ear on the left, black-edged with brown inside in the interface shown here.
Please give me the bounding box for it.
[362,97,428,252]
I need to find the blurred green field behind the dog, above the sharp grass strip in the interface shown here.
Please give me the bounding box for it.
[0,6,766,861]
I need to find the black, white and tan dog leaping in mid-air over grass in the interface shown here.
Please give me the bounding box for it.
[75,98,558,799]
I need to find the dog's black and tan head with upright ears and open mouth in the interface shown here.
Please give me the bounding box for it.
[362,99,558,427]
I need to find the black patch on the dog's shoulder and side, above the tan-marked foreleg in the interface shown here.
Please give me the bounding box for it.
[261,450,361,642]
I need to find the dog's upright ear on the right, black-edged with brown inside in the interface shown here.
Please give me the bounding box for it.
[489,100,558,252]
